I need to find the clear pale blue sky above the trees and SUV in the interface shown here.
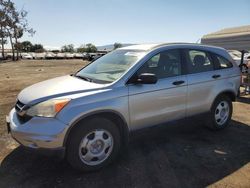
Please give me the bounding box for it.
[14,0,250,47]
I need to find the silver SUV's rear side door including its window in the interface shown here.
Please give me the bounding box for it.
[184,49,217,116]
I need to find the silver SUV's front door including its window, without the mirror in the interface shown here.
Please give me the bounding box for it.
[128,50,187,129]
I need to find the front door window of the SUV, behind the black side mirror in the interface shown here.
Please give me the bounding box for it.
[137,50,181,79]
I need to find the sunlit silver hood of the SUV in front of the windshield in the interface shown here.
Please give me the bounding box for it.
[18,75,105,104]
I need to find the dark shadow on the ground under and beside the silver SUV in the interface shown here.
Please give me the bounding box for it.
[0,119,250,187]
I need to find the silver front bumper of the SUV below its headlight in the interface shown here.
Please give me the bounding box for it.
[6,108,68,151]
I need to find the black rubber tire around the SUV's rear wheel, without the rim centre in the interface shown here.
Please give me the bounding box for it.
[207,95,233,130]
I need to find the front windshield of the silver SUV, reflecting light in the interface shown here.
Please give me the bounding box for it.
[75,50,145,83]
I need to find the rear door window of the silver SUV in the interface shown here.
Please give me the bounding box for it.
[186,50,214,73]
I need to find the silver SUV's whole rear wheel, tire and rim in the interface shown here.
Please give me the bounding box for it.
[209,95,233,130]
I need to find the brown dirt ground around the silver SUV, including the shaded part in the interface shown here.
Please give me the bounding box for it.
[0,60,250,187]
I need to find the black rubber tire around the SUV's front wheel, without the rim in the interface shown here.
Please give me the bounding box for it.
[66,117,121,171]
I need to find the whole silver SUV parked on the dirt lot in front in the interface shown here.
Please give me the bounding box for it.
[6,44,240,171]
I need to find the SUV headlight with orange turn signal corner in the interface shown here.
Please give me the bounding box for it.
[26,99,70,117]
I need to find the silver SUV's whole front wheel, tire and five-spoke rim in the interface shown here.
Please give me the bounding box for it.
[66,118,121,171]
